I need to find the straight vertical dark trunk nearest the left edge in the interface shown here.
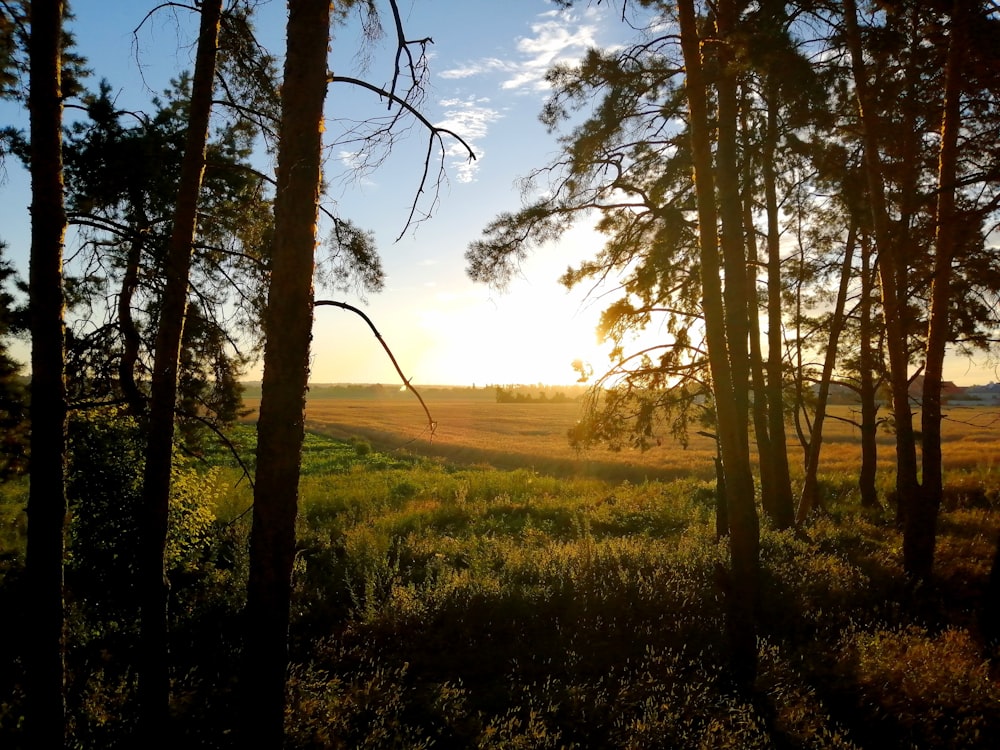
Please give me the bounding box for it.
[24,0,66,748]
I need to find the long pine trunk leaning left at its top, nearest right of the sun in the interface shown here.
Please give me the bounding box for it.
[677,0,760,692]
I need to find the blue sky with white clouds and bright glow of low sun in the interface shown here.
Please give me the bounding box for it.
[0,0,1000,386]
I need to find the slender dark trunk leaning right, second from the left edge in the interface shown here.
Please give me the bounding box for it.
[139,0,222,746]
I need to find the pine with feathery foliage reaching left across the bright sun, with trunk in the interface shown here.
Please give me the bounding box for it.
[466,3,764,689]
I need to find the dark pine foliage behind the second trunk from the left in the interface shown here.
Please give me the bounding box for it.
[58,79,272,420]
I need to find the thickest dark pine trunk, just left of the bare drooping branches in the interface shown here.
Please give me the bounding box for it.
[241,0,330,748]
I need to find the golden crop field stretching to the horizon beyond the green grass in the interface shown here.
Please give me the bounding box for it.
[245,387,1000,480]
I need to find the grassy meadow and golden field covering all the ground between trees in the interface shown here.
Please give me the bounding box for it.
[0,392,1000,750]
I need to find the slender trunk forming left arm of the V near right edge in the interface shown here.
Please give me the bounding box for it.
[844,0,920,528]
